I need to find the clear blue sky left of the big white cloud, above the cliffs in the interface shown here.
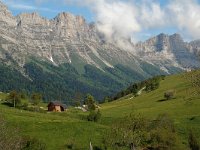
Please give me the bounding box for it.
[2,0,93,22]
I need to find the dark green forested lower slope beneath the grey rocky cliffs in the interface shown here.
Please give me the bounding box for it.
[0,61,165,104]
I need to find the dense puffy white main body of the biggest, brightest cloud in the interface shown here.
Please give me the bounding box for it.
[95,0,141,39]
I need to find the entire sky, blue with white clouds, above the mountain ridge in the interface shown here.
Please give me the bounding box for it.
[2,0,200,41]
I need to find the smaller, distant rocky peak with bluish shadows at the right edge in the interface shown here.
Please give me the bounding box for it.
[135,34,200,71]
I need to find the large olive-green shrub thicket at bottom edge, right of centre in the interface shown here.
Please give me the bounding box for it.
[103,115,176,150]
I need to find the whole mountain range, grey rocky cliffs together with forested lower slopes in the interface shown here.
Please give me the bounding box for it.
[0,2,200,102]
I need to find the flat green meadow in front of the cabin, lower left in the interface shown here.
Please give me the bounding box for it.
[0,105,107,150]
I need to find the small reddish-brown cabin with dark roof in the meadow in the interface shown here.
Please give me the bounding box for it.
[47,101,67,112]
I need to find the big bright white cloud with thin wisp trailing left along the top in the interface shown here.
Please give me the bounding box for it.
[64,0,141,45]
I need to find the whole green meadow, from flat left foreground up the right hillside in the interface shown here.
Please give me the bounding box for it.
[0,71,200,150]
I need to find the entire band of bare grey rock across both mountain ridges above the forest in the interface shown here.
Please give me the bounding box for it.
[0,2,200,74]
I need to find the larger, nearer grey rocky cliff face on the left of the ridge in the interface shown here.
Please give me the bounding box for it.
[0,3,144,74]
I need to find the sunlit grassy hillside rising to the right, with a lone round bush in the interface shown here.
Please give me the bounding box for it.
[102,74,200,147]
